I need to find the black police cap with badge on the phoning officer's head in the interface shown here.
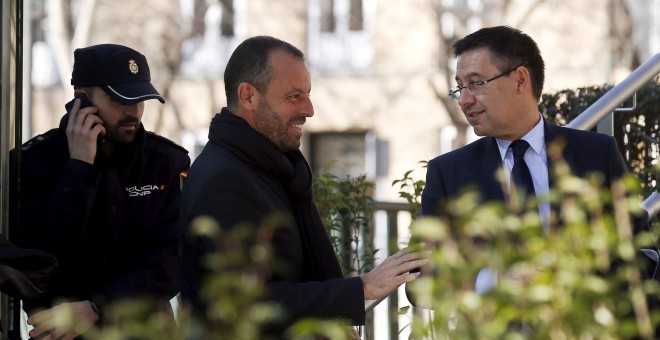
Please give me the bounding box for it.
[71,44,165,105]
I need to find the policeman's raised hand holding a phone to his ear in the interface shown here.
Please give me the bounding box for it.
[66,99,105,164]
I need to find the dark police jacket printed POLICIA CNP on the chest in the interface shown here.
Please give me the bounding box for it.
[16,115,190,311]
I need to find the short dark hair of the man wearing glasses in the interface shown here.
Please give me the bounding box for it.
[452,26,545,100]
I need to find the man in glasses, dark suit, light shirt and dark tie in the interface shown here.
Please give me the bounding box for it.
[422,26,648,308]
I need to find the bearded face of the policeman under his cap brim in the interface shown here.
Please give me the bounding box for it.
[86,87,144,143]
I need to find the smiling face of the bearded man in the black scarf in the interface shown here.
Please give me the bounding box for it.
[246,50,314,152]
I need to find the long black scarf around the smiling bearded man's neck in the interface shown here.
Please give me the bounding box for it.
[209,108,343,281]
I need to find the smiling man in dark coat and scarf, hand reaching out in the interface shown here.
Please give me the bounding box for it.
[181,36,426,338]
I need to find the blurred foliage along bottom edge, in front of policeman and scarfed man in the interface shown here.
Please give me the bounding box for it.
[82,215,360,340]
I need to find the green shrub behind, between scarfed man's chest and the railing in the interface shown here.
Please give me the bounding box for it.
[312,165,377,276]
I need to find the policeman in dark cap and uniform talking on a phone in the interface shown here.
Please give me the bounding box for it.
[13,44,190,339]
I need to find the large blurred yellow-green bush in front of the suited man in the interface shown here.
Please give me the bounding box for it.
[409,156,660,339]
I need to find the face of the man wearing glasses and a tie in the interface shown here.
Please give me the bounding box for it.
[456,48,539,140]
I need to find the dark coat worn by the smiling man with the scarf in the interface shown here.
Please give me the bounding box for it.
[181,109,365,332]
